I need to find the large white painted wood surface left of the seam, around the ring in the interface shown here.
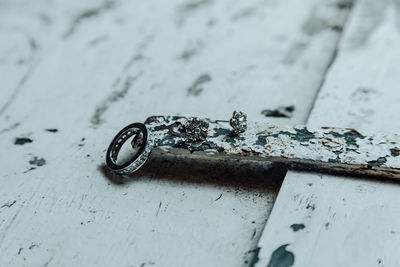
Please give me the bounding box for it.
[0,0,348,266]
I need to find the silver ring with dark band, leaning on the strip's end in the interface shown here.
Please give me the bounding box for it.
[106,123,153,174]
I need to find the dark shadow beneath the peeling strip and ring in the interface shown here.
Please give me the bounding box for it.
[100,154,287,192]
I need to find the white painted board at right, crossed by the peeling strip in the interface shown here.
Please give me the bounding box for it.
[256,0,400,267]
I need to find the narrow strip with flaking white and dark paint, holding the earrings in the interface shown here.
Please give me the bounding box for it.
[145,116,400,178]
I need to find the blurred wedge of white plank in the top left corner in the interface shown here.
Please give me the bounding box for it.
[0,0,88,116]
